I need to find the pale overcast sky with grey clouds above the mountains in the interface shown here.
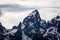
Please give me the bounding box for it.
[0,0,60,29]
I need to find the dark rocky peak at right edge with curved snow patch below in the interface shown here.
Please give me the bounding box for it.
[44,16,60,40]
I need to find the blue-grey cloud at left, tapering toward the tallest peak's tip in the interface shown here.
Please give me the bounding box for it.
[0,4,35,12]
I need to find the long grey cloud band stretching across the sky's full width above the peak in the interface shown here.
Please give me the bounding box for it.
[0,4,60,14]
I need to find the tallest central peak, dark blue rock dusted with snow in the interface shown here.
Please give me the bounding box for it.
[23,10,45,38]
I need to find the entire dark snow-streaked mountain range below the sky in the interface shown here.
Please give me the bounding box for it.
[0,10,60,40]
